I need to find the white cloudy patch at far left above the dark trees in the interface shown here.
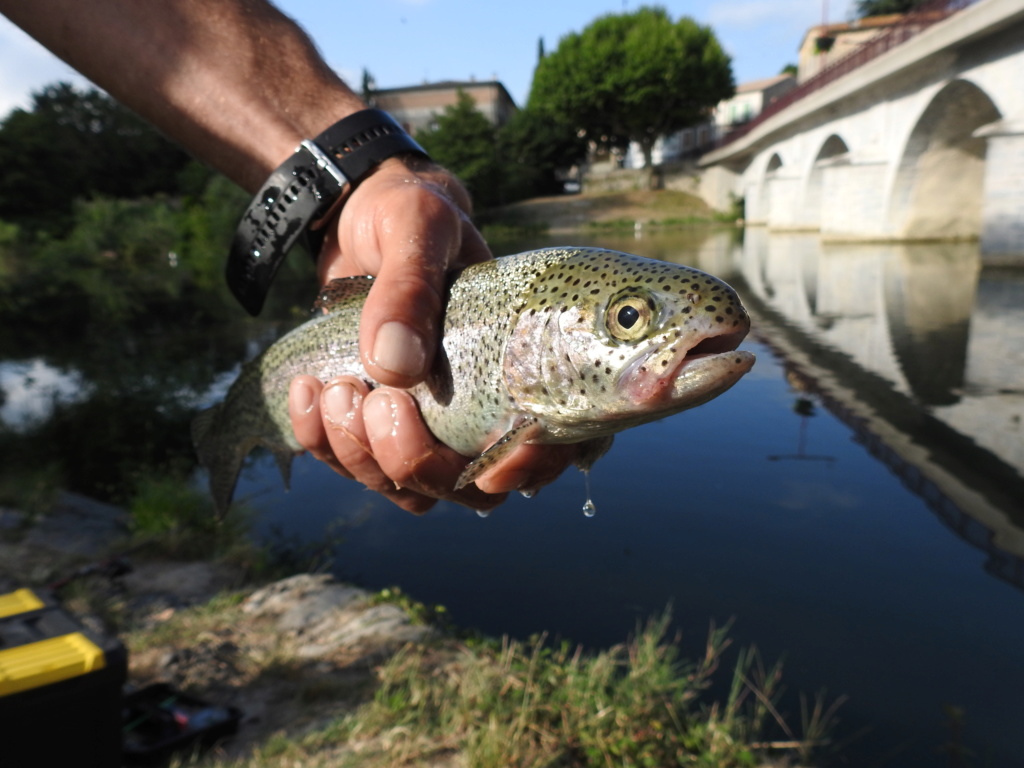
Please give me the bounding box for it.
[0,16,88,120]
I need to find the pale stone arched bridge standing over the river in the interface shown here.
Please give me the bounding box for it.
[701,0,1024,260]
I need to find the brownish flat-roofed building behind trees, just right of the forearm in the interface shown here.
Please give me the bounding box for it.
[370,80,518,136]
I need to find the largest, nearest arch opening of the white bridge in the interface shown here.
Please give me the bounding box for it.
[888,79,1000,240]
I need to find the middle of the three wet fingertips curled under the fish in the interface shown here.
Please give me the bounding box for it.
[321,376,436,514]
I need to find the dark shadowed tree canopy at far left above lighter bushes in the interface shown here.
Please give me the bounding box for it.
[0,83,189,233]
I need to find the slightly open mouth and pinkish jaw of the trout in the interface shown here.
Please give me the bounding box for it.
[624,328,755,410]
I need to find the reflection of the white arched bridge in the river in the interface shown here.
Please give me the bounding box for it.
[705,229,1024,589]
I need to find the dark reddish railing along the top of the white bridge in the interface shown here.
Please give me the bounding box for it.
[715,0,977,148]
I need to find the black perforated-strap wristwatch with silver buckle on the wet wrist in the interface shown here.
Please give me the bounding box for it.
[227,110,429,314]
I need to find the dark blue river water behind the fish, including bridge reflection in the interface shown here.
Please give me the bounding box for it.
[0,229,1024,766]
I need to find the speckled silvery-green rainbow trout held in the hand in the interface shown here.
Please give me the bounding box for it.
[193,248,754,512]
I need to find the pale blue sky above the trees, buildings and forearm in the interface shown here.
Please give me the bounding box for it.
[0,0,853,118]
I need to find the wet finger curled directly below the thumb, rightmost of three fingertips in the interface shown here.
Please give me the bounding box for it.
[364,388,506,510]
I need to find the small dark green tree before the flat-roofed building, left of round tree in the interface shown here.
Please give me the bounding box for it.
[416,90,502,207]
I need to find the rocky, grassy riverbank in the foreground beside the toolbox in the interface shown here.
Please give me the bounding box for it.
[0,494,827,768]
